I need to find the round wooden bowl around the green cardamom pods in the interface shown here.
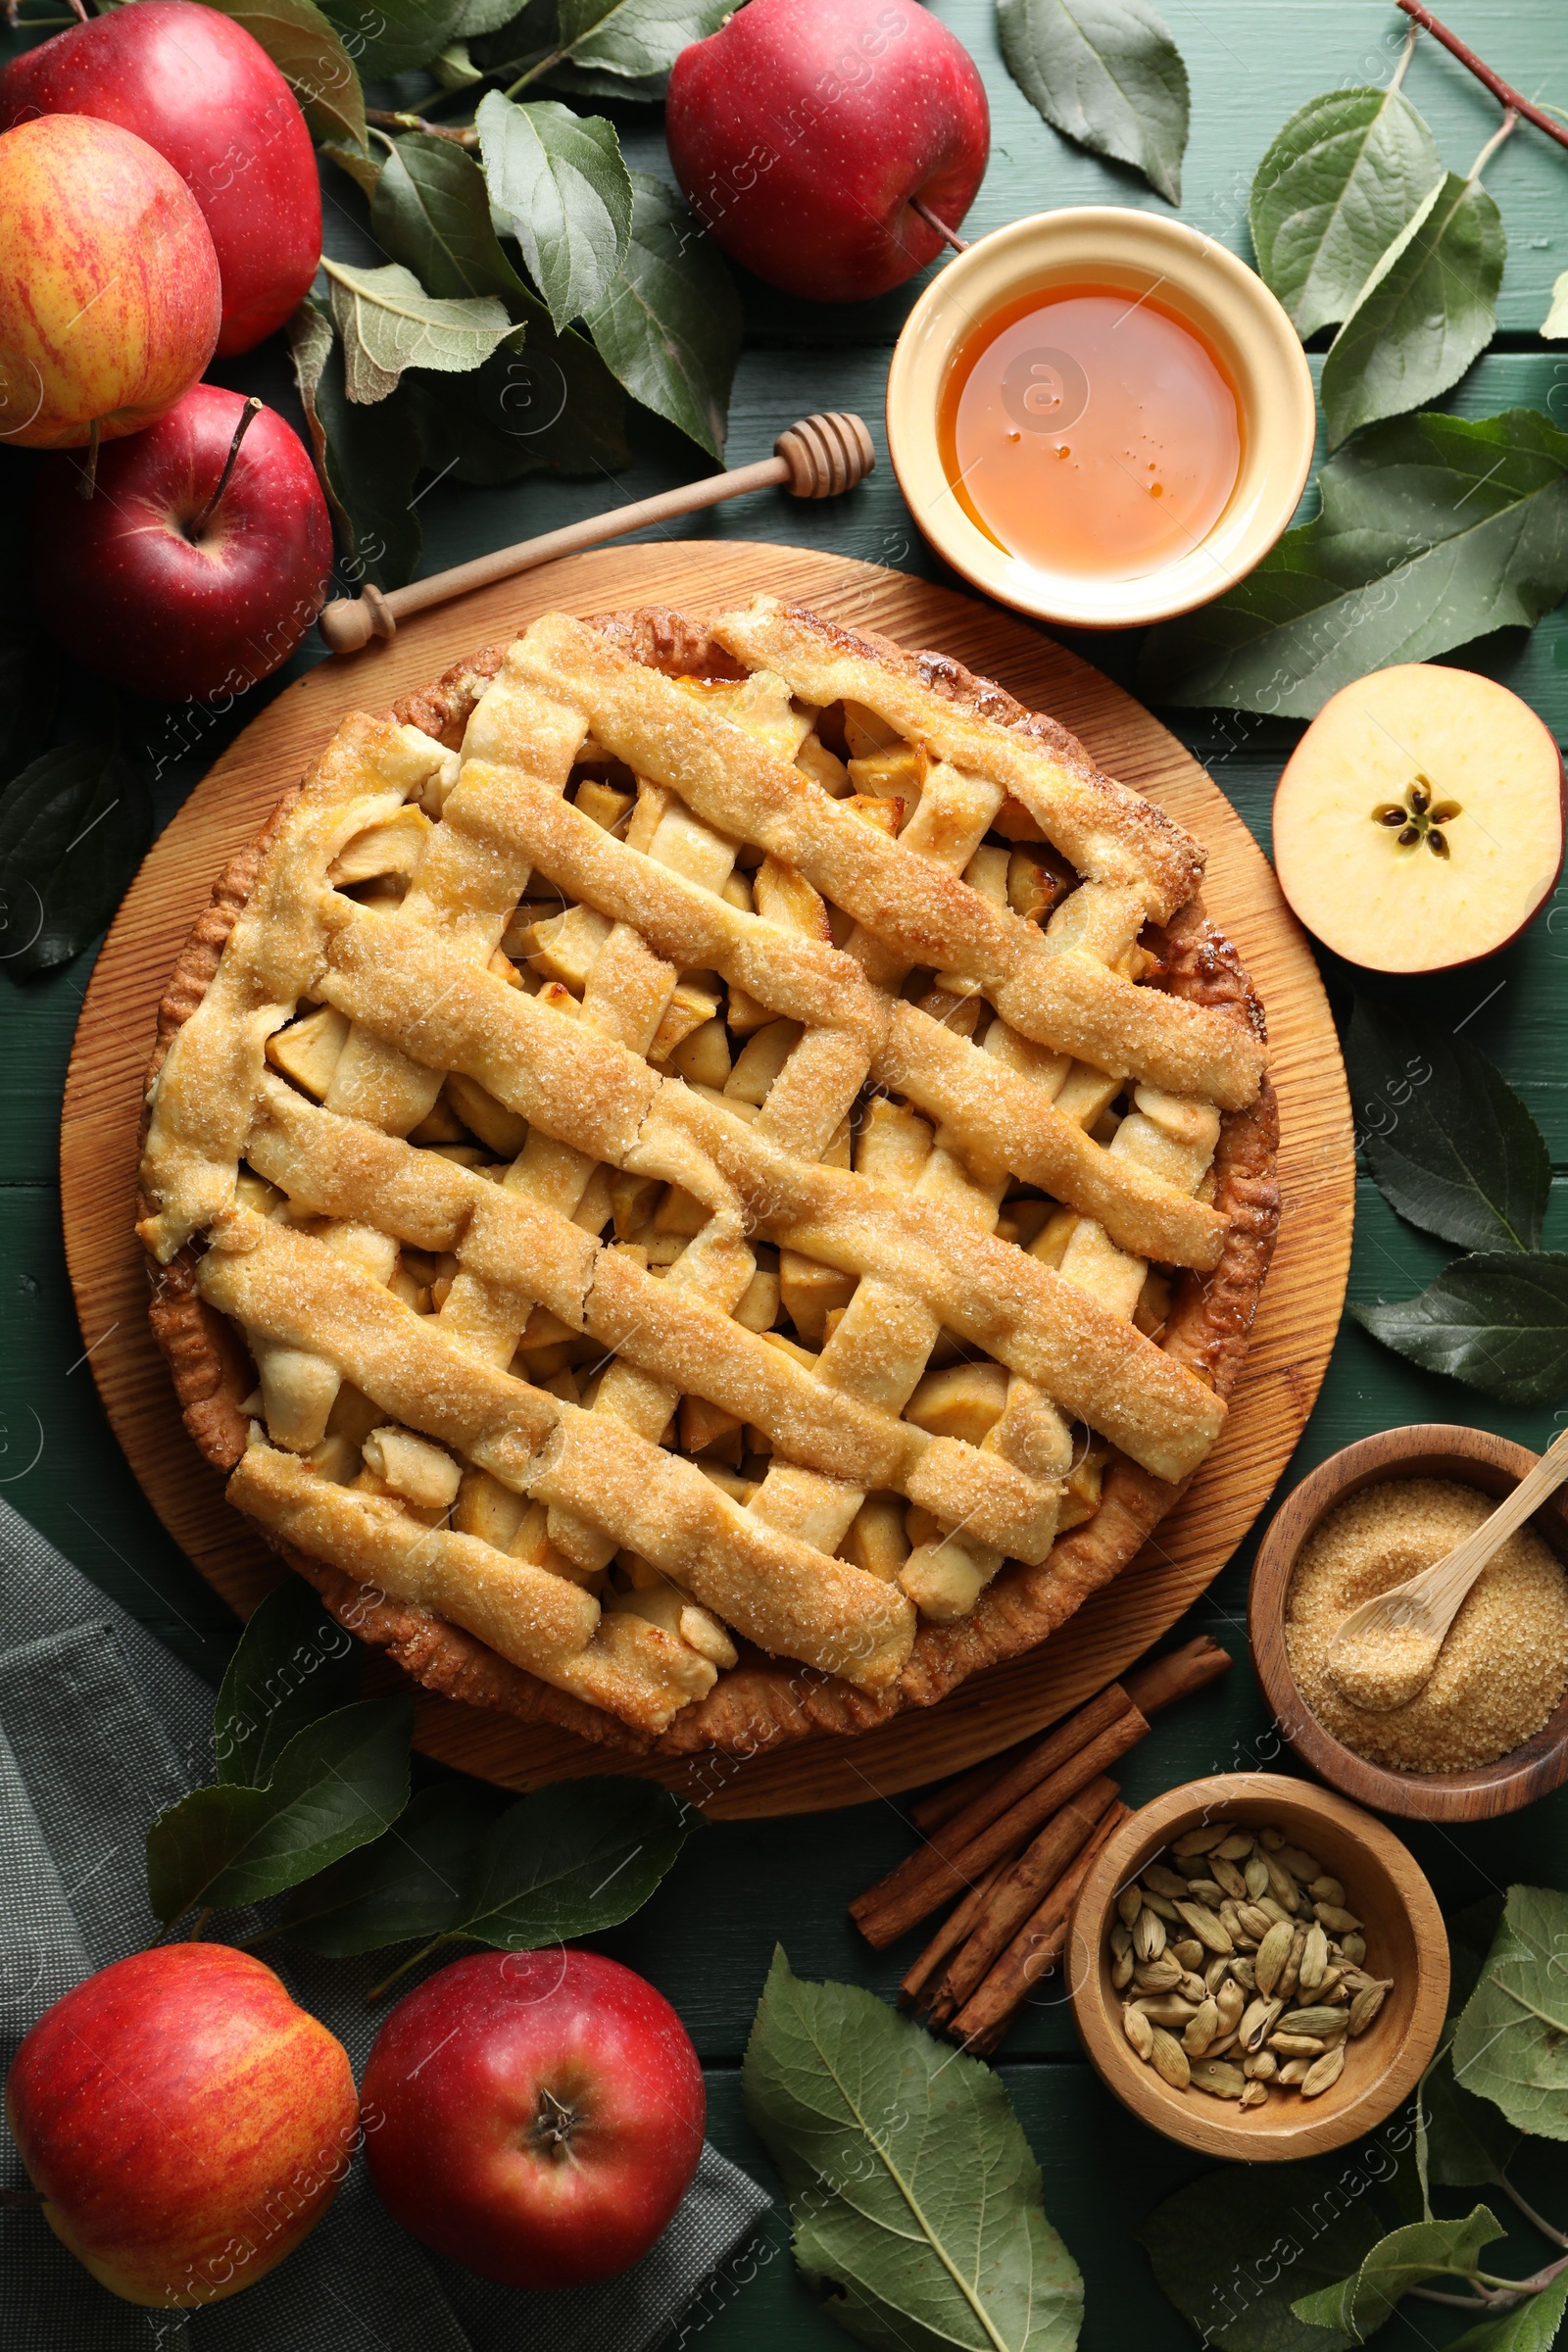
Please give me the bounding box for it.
[1067,1771,1448,2164]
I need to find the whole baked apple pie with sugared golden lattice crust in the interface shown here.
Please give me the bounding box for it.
[139,598,1279,1752]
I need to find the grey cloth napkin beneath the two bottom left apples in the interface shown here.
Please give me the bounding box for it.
[0,1503,768,2352]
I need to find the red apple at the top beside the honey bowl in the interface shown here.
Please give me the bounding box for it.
[665,0,990,301]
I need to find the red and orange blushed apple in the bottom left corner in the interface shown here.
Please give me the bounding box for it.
[5,1942,358,2310]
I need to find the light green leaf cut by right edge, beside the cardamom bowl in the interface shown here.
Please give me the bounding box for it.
[1452,1882,1568,2140]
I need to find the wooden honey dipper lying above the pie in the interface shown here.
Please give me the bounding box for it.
[318,412,877,654]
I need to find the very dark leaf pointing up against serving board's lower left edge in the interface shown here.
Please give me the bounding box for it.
[212,1576,360,1788]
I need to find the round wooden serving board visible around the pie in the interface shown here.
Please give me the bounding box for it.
[61,539,1354,1818]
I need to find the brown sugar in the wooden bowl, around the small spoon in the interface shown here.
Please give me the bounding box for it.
[1286,1477,1568,1771]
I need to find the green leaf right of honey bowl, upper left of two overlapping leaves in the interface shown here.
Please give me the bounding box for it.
[1249,89,1444,341]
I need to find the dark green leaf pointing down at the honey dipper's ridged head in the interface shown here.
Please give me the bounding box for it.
[588,172,741,459]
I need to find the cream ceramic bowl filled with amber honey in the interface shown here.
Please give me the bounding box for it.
[886,205,1316,628]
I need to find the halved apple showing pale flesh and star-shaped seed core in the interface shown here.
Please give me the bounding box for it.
[1274,661,1563,971]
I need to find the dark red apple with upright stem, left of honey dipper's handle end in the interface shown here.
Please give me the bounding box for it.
[33,380,331,701]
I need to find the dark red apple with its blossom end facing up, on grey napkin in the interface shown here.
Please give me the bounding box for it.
[362,1950,706,2286]
